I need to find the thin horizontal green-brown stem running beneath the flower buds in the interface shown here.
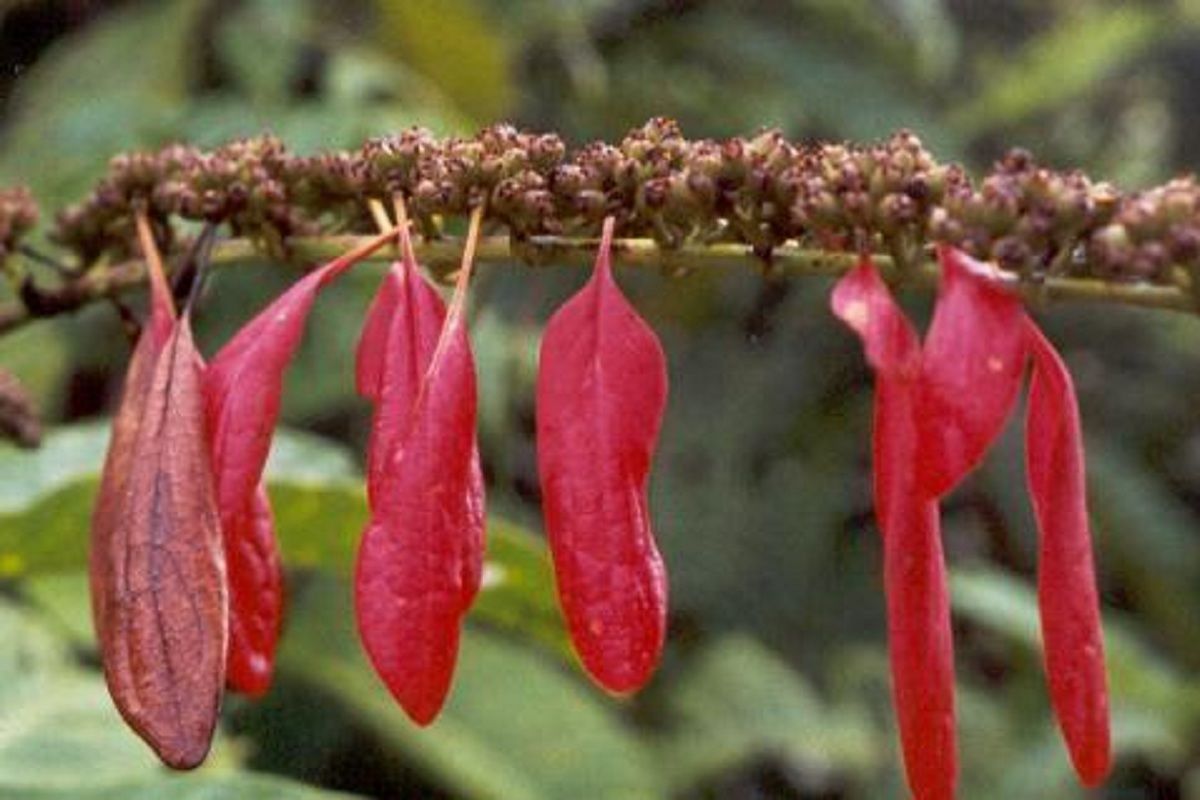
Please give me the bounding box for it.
[0,236,1195,332]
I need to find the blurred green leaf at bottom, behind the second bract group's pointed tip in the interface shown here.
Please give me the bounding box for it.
[271,578,662,800]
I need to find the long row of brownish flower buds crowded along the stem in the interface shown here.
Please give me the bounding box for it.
[7,119,1200,283]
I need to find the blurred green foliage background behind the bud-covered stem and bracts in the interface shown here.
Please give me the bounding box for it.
[0,0,1200,800]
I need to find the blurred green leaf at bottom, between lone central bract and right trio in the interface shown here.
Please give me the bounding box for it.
[659,636,886,793]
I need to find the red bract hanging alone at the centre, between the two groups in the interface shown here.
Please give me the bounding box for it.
[536,217,667,692]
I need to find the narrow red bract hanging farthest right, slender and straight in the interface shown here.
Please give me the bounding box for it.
[1024,320,1111,786]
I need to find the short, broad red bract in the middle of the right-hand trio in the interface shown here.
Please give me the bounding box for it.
[918,247,1026,497]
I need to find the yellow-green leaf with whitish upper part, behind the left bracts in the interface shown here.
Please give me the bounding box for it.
[0,422,569,656]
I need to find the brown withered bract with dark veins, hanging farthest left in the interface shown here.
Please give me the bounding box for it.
[91,314,228,769]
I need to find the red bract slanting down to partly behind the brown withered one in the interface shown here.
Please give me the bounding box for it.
[205,227,395,696]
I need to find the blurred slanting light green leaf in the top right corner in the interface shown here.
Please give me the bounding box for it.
[950,4,1170,136]
